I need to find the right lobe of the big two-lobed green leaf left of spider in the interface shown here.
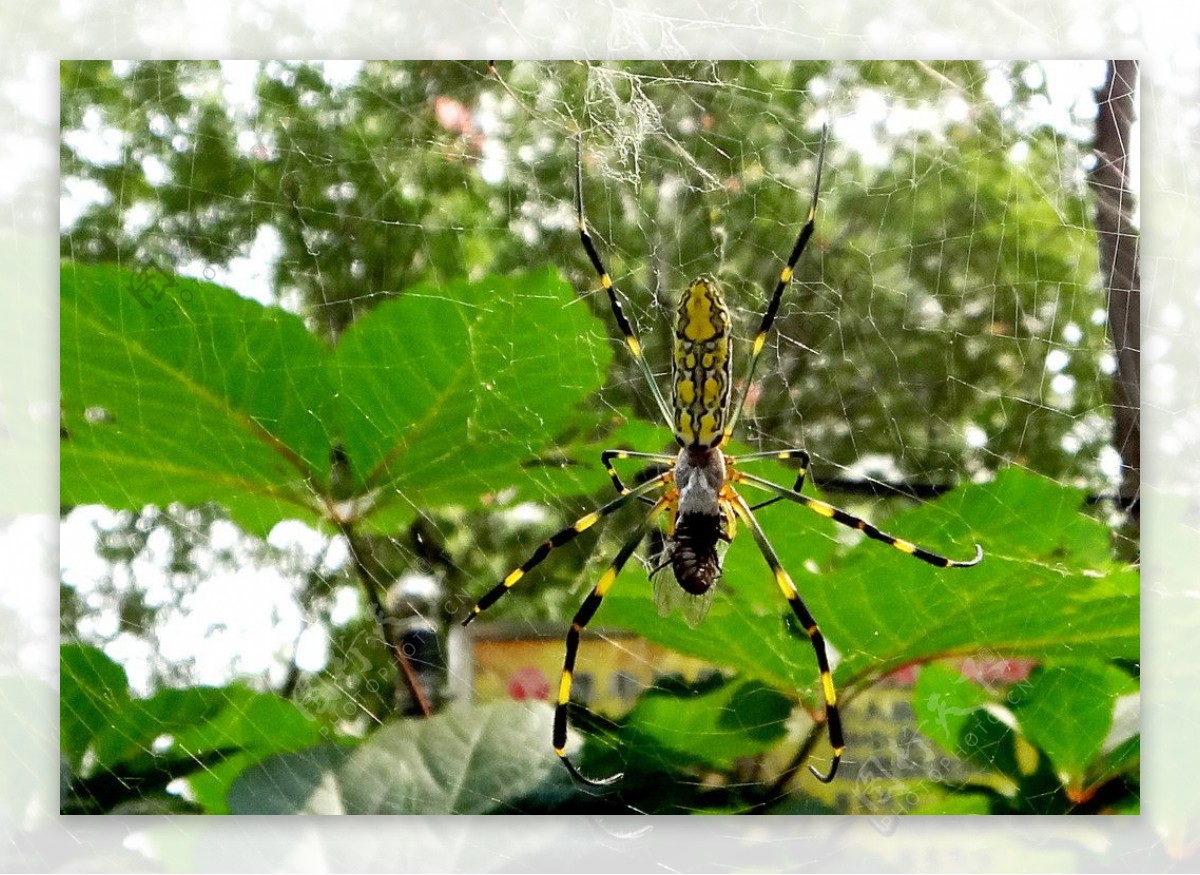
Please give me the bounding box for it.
[335,269,611,528]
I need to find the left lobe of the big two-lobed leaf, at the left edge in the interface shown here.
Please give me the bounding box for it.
[60,264,332,534]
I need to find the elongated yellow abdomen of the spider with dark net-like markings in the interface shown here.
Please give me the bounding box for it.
[671,276,733,450]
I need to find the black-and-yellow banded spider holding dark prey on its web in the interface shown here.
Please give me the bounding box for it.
[463,126,983,786]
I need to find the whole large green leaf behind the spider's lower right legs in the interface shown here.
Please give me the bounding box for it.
[595,469,1139,690]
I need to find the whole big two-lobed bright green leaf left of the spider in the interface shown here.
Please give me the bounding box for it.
[61,264,611,533]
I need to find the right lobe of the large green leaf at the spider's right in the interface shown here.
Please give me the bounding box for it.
[812,468,1140,679]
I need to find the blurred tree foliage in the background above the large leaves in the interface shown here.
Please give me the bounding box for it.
[61,62,1109,491]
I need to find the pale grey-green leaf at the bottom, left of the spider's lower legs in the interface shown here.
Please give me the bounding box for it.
[229,702,562,814]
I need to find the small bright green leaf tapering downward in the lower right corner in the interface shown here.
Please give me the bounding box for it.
[1013,664,1136,787]
